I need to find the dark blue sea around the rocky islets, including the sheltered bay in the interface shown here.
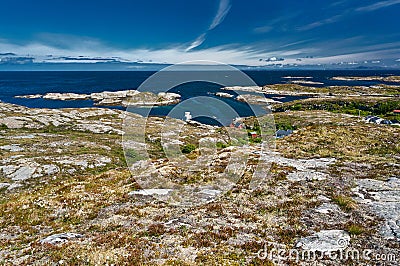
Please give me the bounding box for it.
[0,70,400,125]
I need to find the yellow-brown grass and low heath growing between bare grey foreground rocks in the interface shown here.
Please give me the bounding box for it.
[0,101,399,265]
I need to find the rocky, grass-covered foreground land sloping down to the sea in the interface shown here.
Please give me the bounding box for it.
[0,96,400,265]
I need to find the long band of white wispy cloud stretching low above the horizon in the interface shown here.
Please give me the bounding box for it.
[0,32,400,66]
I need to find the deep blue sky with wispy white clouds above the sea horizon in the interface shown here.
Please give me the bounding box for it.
[0,0,400,70]
